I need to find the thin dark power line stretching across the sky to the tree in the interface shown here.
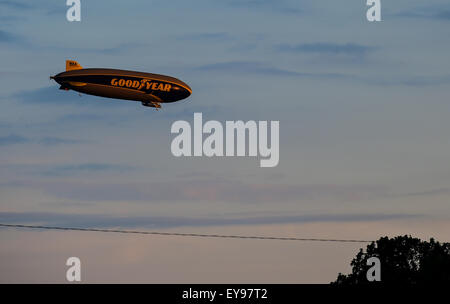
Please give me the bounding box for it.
[0,223,372,243]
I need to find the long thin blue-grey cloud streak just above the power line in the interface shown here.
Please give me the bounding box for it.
[0,212,421,229]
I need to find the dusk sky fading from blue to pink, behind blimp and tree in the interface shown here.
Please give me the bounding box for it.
[0,0,450,283]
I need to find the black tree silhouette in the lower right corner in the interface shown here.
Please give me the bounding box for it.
[332,235,450,285]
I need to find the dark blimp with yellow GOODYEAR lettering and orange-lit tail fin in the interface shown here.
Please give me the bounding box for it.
[50,60,192,110]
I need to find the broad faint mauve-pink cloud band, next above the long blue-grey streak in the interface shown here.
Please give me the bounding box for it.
[10,179,389,203]
